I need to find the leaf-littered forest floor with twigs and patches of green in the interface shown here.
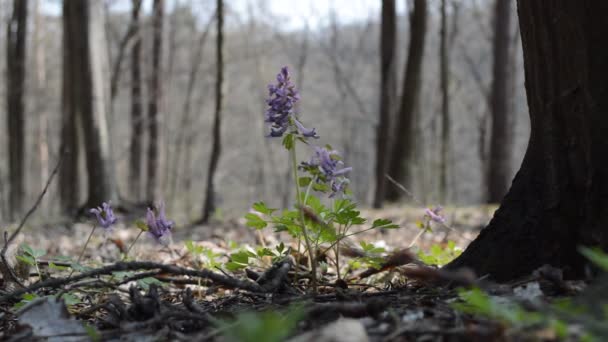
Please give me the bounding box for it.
[0,207,600,341]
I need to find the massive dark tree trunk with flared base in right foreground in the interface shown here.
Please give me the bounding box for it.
[447,0,608,281]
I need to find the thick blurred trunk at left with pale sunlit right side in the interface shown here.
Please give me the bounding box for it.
[63,0,118,207]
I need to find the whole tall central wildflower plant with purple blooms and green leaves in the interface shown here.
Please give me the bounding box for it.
[242,67,398,292]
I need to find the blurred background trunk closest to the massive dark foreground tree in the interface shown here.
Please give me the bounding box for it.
[487,0,512,203]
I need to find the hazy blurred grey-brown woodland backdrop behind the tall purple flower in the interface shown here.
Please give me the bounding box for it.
[0,0,529,223]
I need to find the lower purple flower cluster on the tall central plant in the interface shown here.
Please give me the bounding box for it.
[300,146,353,198]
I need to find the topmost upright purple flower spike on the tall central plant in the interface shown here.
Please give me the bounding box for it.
[265,67,318,138]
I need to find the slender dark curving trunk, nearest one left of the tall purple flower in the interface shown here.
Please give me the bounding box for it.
[200,0,224,223]
